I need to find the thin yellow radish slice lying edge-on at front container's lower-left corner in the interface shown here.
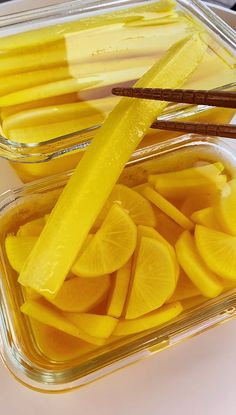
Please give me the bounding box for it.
[20,299,104,346]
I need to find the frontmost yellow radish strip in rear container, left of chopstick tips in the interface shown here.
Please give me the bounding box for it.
[3,98,114,143]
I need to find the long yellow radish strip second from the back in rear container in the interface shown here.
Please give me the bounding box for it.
[0,21,182,77]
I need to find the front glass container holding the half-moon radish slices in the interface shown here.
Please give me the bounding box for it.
[0,135,236,393]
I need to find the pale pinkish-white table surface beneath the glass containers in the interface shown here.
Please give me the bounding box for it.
[0,0,236,415]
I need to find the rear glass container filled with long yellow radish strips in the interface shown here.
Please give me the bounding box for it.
[0,0,236,181]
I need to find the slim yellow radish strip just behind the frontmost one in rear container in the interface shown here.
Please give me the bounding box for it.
[0,77,100,107]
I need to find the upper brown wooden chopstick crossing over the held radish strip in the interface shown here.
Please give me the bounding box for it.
[112,87,236,108]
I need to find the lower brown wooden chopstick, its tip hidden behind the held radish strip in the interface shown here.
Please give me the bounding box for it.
[151,121,236,138]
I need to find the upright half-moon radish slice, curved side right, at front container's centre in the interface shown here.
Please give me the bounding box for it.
[125,237,176,319]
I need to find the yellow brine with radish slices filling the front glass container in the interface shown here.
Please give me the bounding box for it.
[1,137,236,370]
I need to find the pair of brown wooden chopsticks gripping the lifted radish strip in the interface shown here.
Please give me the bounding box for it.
[112,87,236,138]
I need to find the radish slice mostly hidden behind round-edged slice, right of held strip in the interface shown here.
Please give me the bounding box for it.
[93,184,156,227]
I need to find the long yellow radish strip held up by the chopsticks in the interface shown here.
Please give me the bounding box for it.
[19,36,206,298]
